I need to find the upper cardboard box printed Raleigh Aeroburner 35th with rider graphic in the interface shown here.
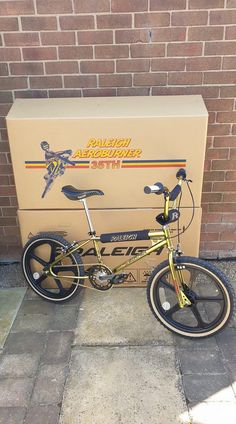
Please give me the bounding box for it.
[7,96,208,209]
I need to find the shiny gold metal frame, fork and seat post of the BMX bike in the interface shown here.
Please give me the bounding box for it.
[45,180,191,307]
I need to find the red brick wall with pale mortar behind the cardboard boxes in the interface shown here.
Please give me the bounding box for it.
[0,0,236,257]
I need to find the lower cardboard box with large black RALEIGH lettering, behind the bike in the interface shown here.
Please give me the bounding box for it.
[18,208,201,287]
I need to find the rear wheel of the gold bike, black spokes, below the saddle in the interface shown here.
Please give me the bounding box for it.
[22,233,84,302]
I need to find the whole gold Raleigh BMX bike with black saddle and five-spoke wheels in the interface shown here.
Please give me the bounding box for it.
[22,169,235,338]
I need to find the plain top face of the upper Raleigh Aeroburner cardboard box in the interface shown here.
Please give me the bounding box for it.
[7,95,208,120]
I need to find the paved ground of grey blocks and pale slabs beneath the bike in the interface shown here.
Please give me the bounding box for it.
[0,262,236,424]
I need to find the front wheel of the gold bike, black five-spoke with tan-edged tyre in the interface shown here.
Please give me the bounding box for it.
[147,257,235,338]
